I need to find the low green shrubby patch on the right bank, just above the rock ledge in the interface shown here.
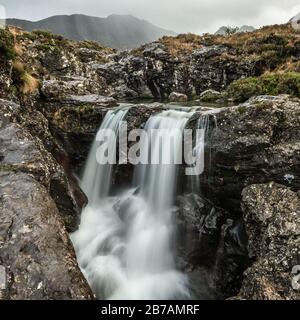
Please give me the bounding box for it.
[226,72,300,102]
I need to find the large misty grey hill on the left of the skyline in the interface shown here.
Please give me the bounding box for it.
[6,14,175,49]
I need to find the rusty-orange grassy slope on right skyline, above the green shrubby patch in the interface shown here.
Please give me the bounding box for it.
[160,24,300,73]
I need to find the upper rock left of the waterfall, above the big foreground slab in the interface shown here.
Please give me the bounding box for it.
[0,100,86,231]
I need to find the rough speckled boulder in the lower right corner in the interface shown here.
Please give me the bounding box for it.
[238,183,300,300]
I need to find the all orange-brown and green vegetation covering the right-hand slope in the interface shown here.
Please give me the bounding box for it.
[160,24,300,102]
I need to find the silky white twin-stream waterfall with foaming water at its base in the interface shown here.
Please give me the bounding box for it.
[72,110,192,299]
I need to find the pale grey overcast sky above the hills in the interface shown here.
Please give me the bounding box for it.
[0,0,300,33]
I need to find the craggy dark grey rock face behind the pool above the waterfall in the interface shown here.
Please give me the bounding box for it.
[97,43,258,98]
